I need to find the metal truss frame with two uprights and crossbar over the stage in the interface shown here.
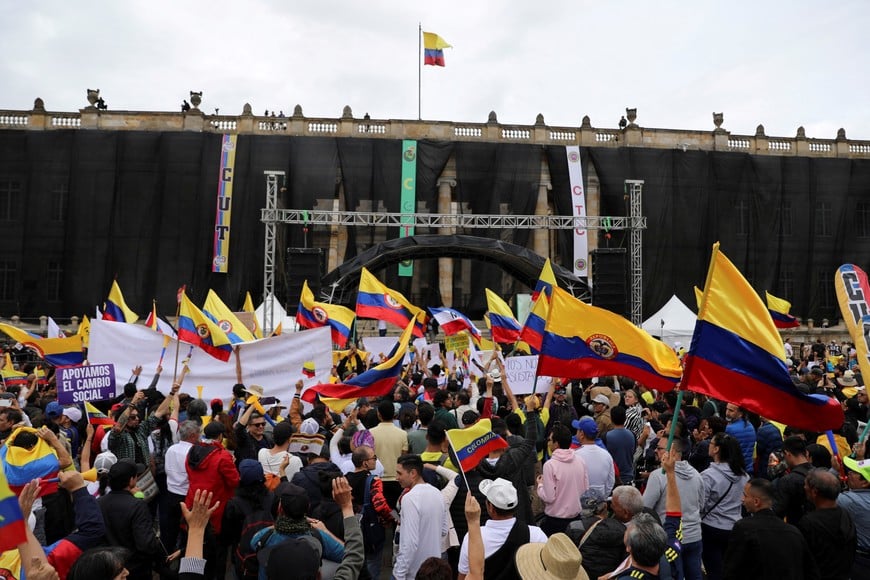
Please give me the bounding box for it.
[260,171,646,333]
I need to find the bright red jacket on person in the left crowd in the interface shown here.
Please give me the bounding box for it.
[184,443,239,533]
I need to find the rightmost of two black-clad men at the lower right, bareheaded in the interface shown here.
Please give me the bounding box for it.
[798,468,858,578]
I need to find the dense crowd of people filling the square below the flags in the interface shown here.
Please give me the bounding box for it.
[0,336,870,580]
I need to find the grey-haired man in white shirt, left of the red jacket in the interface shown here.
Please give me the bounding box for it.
[160,420,202,552]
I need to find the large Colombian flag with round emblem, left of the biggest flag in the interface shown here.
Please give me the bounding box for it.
[538,288,682,391]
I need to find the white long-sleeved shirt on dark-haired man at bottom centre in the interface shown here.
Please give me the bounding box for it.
[393,483,450,580]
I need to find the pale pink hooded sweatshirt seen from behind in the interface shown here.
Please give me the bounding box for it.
[538,449,589,518]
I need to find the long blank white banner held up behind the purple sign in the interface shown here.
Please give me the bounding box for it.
[88,320,332,404]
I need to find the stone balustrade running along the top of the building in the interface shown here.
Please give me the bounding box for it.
[0,99,870,158]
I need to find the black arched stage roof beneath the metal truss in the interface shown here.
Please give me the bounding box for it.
[321,234,590,303]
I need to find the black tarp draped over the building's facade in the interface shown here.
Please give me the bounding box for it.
[0,130,870,319]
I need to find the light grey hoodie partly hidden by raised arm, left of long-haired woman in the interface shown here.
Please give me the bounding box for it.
[643,460,704,544]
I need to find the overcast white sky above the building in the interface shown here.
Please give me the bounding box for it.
[0,0,870,139]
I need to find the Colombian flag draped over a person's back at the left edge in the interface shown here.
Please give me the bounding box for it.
[0,427,60,498]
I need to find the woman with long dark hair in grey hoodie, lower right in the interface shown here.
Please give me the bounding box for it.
[701,433,749,580]
